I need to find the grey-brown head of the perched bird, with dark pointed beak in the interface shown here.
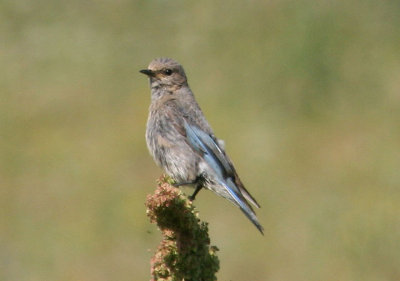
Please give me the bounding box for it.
[140,58,187,88]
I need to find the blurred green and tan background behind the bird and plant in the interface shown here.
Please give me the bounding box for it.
[0,0,400,281]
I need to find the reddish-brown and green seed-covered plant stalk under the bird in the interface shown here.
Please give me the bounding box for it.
[146,176,219,281]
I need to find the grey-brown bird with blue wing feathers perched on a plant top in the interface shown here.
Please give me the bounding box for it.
[140,58,264,234]
